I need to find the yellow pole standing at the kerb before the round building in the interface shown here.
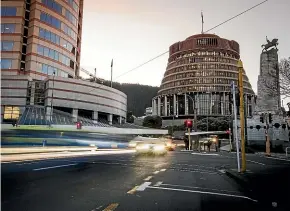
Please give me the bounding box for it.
[238,60,246,172]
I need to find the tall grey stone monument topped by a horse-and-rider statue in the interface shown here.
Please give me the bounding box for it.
[255,37,281,115]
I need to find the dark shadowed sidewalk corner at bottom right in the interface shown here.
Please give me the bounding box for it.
[225,166,290,210]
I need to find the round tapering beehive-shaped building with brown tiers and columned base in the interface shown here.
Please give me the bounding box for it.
[152,34,255,120]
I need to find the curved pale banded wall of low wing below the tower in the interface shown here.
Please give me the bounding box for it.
[45,76,127,117]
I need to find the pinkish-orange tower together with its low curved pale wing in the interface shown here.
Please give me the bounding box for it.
[1,0,127,122]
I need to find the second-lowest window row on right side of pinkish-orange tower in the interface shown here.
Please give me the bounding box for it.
[39,28,75,54]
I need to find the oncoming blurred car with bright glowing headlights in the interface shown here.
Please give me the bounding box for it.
[135,142,167,155]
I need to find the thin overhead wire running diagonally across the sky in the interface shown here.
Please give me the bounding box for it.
[84,0,269,92]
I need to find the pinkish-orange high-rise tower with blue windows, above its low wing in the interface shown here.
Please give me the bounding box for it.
[1,0,83,80]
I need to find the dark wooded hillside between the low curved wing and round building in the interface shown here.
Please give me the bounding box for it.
[104,81,159,117]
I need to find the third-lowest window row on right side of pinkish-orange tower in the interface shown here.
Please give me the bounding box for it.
[40,12,77,40]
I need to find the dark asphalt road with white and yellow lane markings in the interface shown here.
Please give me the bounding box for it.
[1,152,289,211]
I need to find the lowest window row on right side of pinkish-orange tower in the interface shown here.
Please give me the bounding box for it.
[37,45,74,69]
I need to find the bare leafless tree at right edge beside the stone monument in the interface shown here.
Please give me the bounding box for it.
[265,57,290,97]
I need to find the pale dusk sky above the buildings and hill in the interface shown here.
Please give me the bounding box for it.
[81,0,290,105]
